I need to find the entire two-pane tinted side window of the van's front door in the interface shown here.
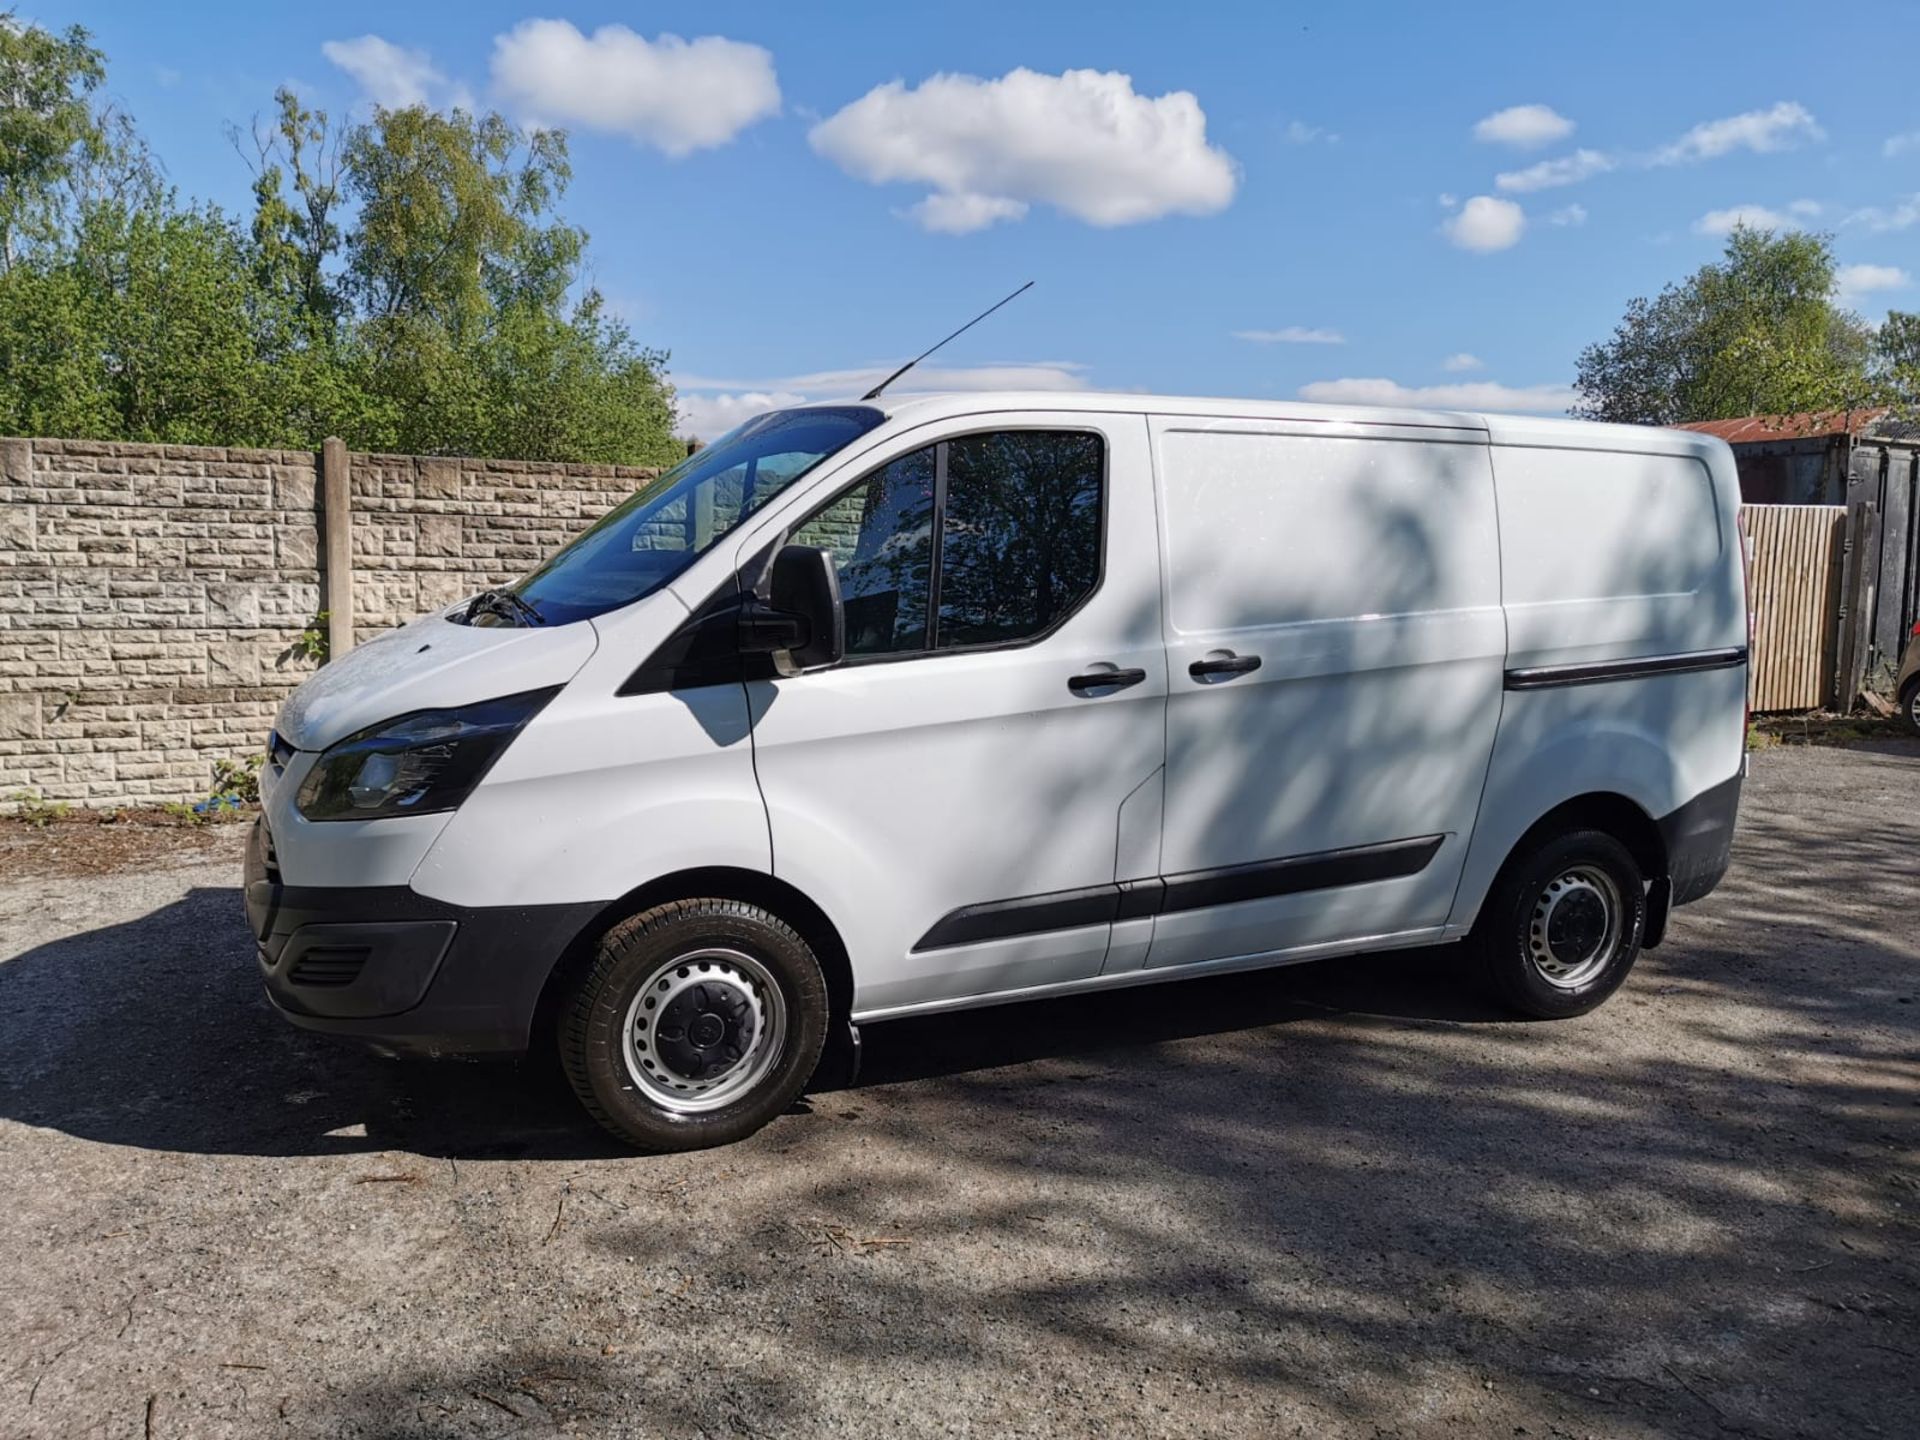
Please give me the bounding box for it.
[793,430,1104,659]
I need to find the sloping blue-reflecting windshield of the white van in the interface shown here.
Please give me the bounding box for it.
[491,405,887,624]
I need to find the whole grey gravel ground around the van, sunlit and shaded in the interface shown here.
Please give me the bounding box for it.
[0,743,1920,1436]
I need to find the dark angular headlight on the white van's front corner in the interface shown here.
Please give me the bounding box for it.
[300,689,559,820]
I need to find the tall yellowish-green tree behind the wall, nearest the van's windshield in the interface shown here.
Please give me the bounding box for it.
[342,106,676,463]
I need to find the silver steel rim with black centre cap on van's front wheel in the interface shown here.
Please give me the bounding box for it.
[620,947,787,1116]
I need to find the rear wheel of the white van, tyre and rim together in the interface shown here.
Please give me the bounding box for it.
[1467,829,1647,1020]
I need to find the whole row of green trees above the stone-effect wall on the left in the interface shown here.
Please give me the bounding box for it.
[0,13,678,463]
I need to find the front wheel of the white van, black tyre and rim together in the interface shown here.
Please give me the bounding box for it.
[559,900,828,1150]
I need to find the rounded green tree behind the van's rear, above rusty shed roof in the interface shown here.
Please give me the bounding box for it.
[1574,227,1876,424]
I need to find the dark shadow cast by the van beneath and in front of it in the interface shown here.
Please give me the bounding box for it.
[0,887,1494,1160]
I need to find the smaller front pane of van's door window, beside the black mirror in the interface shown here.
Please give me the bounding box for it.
[793,445,933,655]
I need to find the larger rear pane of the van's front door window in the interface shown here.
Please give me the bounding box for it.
[939,430,1102,649]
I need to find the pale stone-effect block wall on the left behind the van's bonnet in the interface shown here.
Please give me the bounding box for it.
[0,440,655,806]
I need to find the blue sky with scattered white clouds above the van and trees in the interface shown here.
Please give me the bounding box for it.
[41,0,1920,436]
